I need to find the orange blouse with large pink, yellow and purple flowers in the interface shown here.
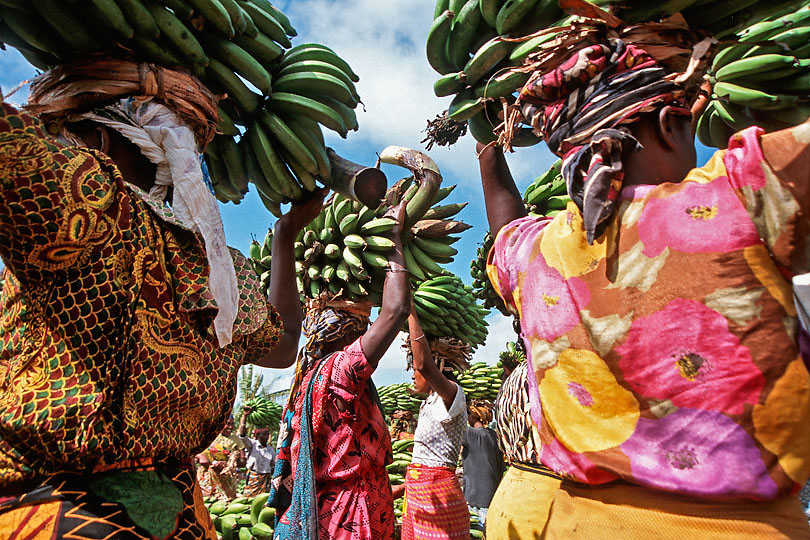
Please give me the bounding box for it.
[487,127,810,500]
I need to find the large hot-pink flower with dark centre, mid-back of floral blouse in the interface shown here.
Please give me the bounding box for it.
[616,298,765,414]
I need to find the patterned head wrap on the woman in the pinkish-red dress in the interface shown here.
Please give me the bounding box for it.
[287,298,371,409]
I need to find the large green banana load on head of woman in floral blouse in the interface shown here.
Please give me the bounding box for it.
[425,0,810,151]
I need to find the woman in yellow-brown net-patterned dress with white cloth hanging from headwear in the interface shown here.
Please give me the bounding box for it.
[0,56,322,539]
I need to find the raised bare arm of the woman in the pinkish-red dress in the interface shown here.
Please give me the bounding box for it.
[360,201,411,369]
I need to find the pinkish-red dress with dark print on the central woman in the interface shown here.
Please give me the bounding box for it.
[282,339,394,540]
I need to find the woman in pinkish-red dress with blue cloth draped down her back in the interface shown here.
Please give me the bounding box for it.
[268,202,411,540]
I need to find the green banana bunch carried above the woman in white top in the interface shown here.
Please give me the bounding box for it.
[413,275,489,348]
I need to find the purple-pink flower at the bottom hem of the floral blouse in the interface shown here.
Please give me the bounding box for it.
[621,408,777,499]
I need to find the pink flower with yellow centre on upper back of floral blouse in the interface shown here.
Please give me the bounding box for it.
[638,177,760,257]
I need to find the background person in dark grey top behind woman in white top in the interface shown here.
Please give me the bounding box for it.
[461,400,498,528]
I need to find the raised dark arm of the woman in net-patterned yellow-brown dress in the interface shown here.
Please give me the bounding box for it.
[256,189,326,368]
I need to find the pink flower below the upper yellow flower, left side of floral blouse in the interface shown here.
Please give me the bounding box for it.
[519,253,591,341]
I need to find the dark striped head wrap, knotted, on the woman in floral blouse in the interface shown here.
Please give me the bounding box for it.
[518,38,689,244]
